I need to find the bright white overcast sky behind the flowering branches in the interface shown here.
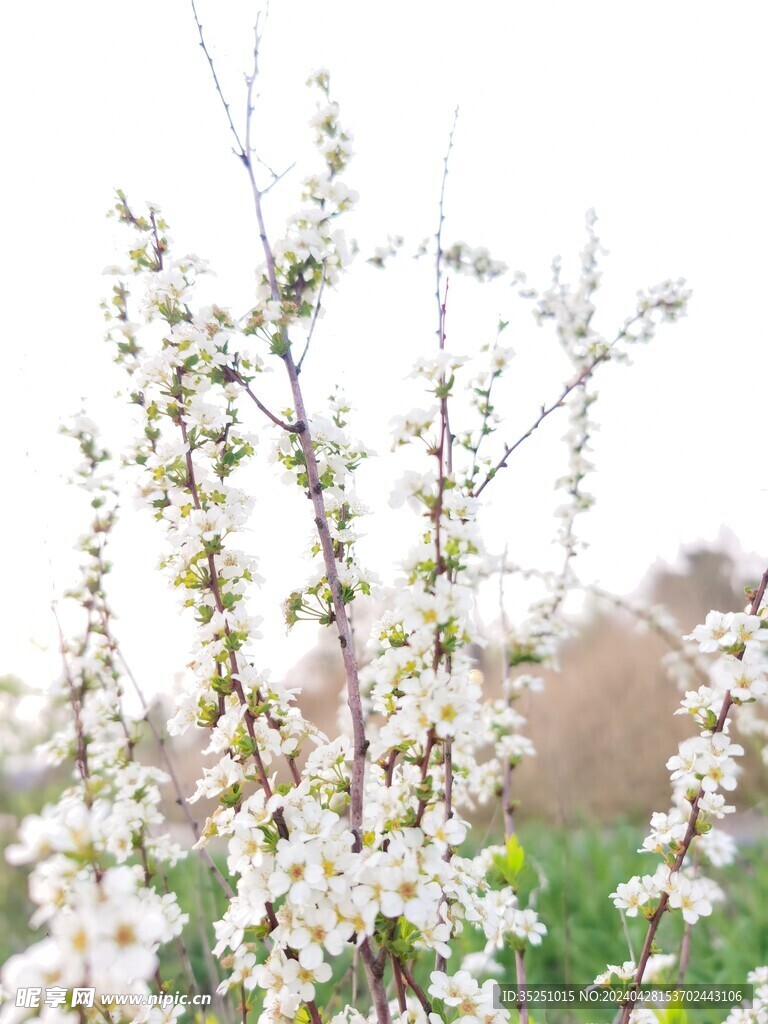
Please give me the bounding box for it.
[0,0,768,704]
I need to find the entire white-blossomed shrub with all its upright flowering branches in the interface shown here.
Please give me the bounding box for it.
[3,4,768,1024]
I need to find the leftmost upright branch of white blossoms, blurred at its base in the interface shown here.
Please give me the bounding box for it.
[2,425,186,1022]
